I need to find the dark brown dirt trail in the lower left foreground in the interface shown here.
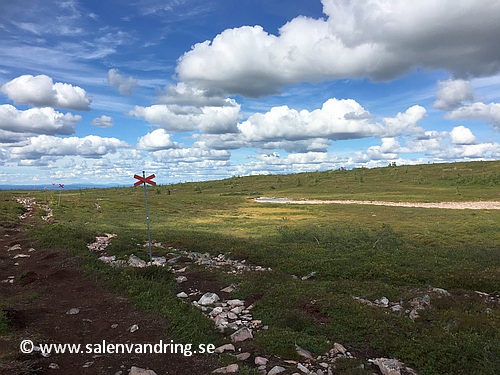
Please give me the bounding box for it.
[0,201,219,375]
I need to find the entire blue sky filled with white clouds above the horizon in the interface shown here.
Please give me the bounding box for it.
[0,0,500,185]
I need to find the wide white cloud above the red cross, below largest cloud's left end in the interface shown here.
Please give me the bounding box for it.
[129,99,240,134]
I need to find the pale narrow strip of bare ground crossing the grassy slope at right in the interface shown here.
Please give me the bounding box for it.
[254,197,500,210]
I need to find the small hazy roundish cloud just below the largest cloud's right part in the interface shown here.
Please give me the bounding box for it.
[434,79,474,111]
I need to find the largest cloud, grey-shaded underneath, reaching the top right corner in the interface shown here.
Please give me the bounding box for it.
[176,0,500,97]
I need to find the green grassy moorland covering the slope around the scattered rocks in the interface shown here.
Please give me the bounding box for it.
[2,162,500,374]
